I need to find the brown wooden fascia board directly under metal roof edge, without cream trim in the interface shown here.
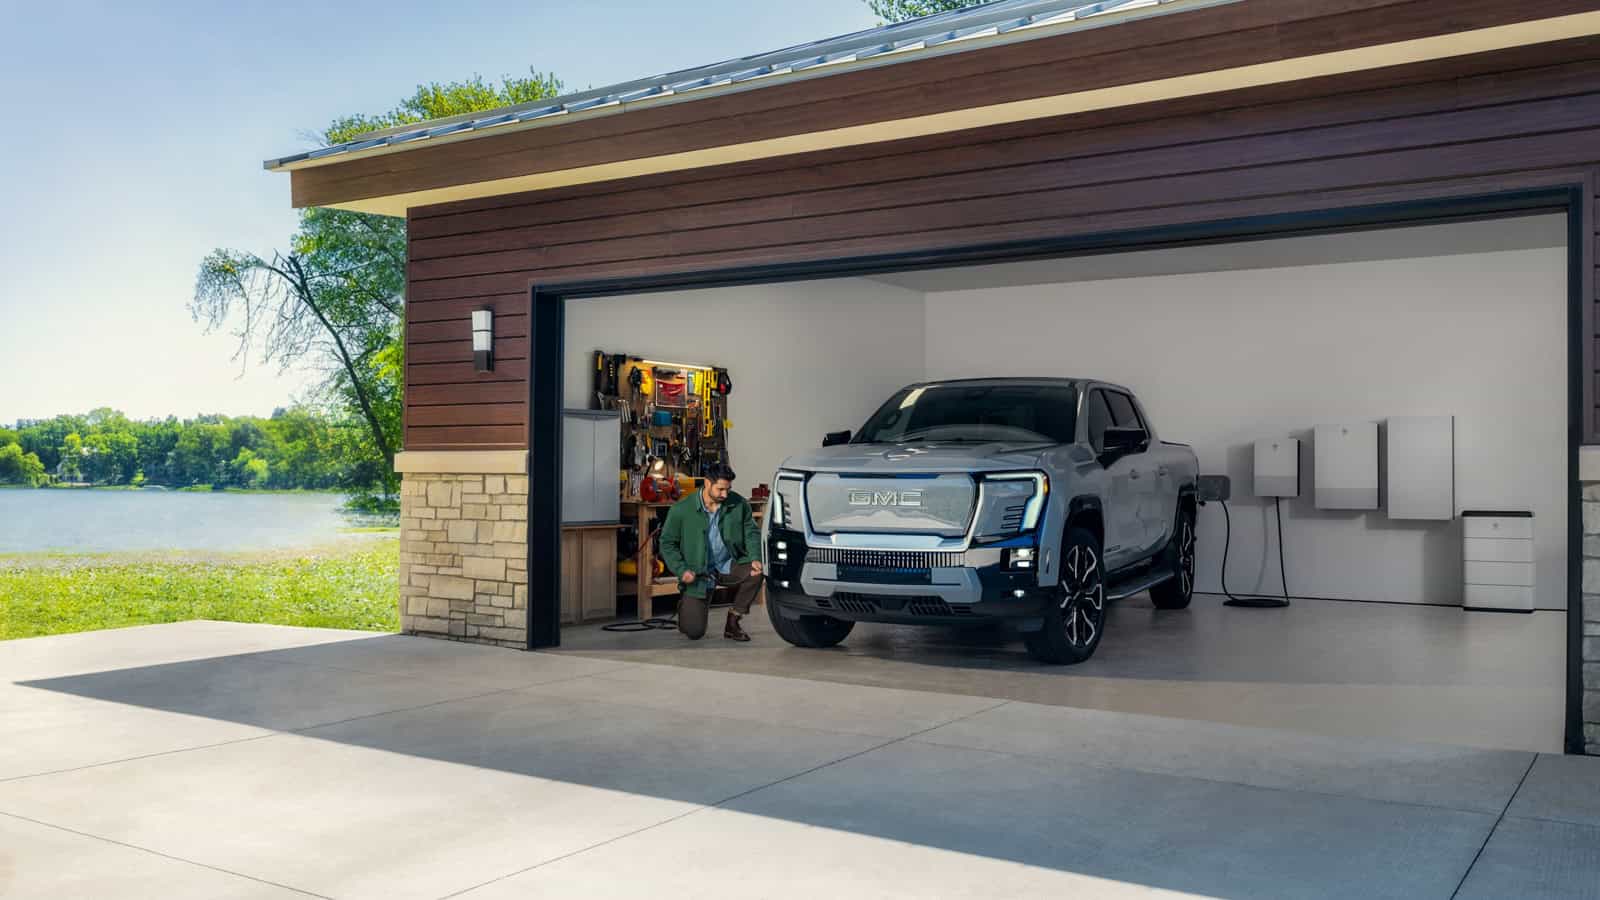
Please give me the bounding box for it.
[291,0,1595,207]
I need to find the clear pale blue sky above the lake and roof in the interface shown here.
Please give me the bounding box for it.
[0,0,875,423]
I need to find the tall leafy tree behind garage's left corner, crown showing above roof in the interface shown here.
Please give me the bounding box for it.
[189,72,562,495]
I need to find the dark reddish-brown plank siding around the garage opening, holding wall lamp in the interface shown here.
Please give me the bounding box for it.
[396,36,1600,450]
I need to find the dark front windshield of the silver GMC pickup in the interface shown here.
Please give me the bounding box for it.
[854,384,1078,444]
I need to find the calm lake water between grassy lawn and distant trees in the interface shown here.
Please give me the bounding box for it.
[0,490,366,554]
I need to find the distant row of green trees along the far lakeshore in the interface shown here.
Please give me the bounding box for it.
[0,407,389,495]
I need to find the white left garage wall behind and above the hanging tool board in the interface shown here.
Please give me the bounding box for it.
[565,279,925,493]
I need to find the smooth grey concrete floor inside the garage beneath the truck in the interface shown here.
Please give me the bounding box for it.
[560,594,1566,753]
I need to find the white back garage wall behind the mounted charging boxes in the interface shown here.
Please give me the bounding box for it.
[926,248,1566,609]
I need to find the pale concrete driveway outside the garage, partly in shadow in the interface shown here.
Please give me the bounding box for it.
[0,621,1600,900]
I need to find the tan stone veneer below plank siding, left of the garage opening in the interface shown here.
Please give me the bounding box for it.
[400,472,528,649]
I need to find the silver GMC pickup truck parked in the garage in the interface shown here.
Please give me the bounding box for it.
[763,378,1198,663]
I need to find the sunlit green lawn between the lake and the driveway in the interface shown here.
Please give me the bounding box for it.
[0,536,400,641]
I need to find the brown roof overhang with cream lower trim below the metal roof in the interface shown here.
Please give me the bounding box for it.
[280,0,1600,216]
